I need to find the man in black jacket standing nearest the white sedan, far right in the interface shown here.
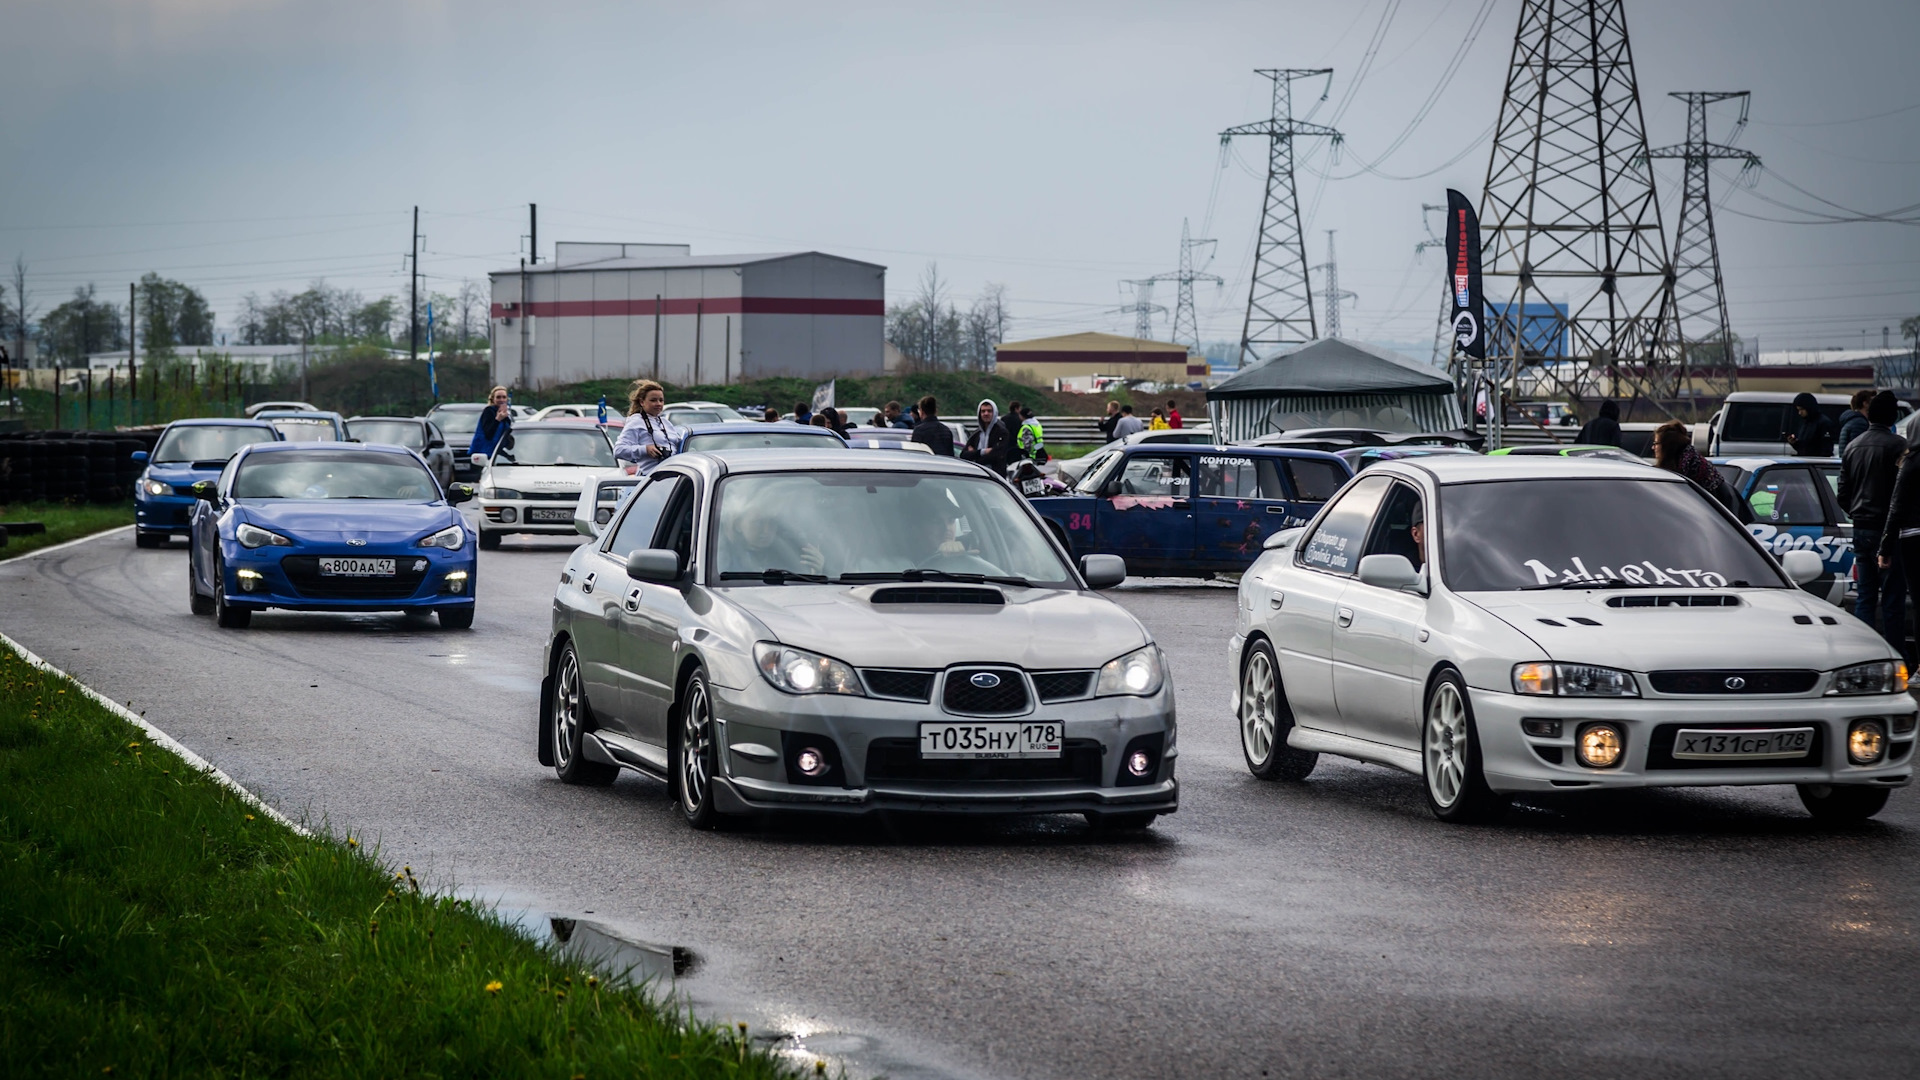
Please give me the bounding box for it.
[1839,390,1907,655]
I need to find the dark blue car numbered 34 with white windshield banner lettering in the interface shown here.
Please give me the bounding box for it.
[1033,442,1352,577]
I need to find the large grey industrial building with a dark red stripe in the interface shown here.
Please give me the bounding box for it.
[488,242,887,386]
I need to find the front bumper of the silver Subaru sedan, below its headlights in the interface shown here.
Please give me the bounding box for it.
[712,668,1179,815]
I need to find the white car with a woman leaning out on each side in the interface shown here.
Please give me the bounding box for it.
[480,421,626,548]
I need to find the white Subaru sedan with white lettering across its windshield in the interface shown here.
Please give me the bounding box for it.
[1231,457,1914,821]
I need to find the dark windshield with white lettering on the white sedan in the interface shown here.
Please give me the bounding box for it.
[1440,479,1786,592]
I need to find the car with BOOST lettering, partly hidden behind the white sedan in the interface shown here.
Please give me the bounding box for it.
[1709,457,1855,609]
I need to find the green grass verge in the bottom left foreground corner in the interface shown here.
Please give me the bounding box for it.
[0,646,795,1080]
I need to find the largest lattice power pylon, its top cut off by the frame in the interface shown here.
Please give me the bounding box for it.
[1448,0,1686,417]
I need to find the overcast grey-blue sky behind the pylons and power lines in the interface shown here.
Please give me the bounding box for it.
[0,0,1920,356]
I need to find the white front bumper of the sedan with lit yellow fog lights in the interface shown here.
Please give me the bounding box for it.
[1471,688,1914,792]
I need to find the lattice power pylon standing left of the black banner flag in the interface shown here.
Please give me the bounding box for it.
[1219,67,1340,365]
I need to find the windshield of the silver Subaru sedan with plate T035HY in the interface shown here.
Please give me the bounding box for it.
[712,471,1073,588]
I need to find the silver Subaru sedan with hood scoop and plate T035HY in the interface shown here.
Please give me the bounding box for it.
[540,450,1179,828]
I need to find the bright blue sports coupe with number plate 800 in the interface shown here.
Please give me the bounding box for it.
[186,442,478,630]
